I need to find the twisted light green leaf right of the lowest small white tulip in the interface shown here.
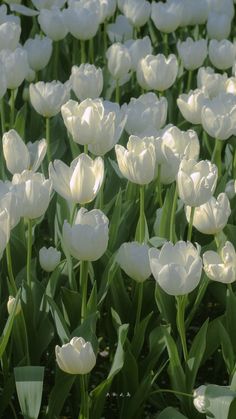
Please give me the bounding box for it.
[90,324,129,419]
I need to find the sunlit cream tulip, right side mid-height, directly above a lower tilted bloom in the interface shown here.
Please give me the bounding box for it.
[177,159,218,207]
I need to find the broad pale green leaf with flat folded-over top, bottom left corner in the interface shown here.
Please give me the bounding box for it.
[14,366,44,419]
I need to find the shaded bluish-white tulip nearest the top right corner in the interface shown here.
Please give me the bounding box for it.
[207,12,231,41]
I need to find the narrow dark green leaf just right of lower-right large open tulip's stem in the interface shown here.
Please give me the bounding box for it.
[186,319,209,392]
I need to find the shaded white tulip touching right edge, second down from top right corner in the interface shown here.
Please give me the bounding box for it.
[209,39,235,70]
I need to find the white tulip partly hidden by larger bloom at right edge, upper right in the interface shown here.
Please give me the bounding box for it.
[177,89,208,125]
